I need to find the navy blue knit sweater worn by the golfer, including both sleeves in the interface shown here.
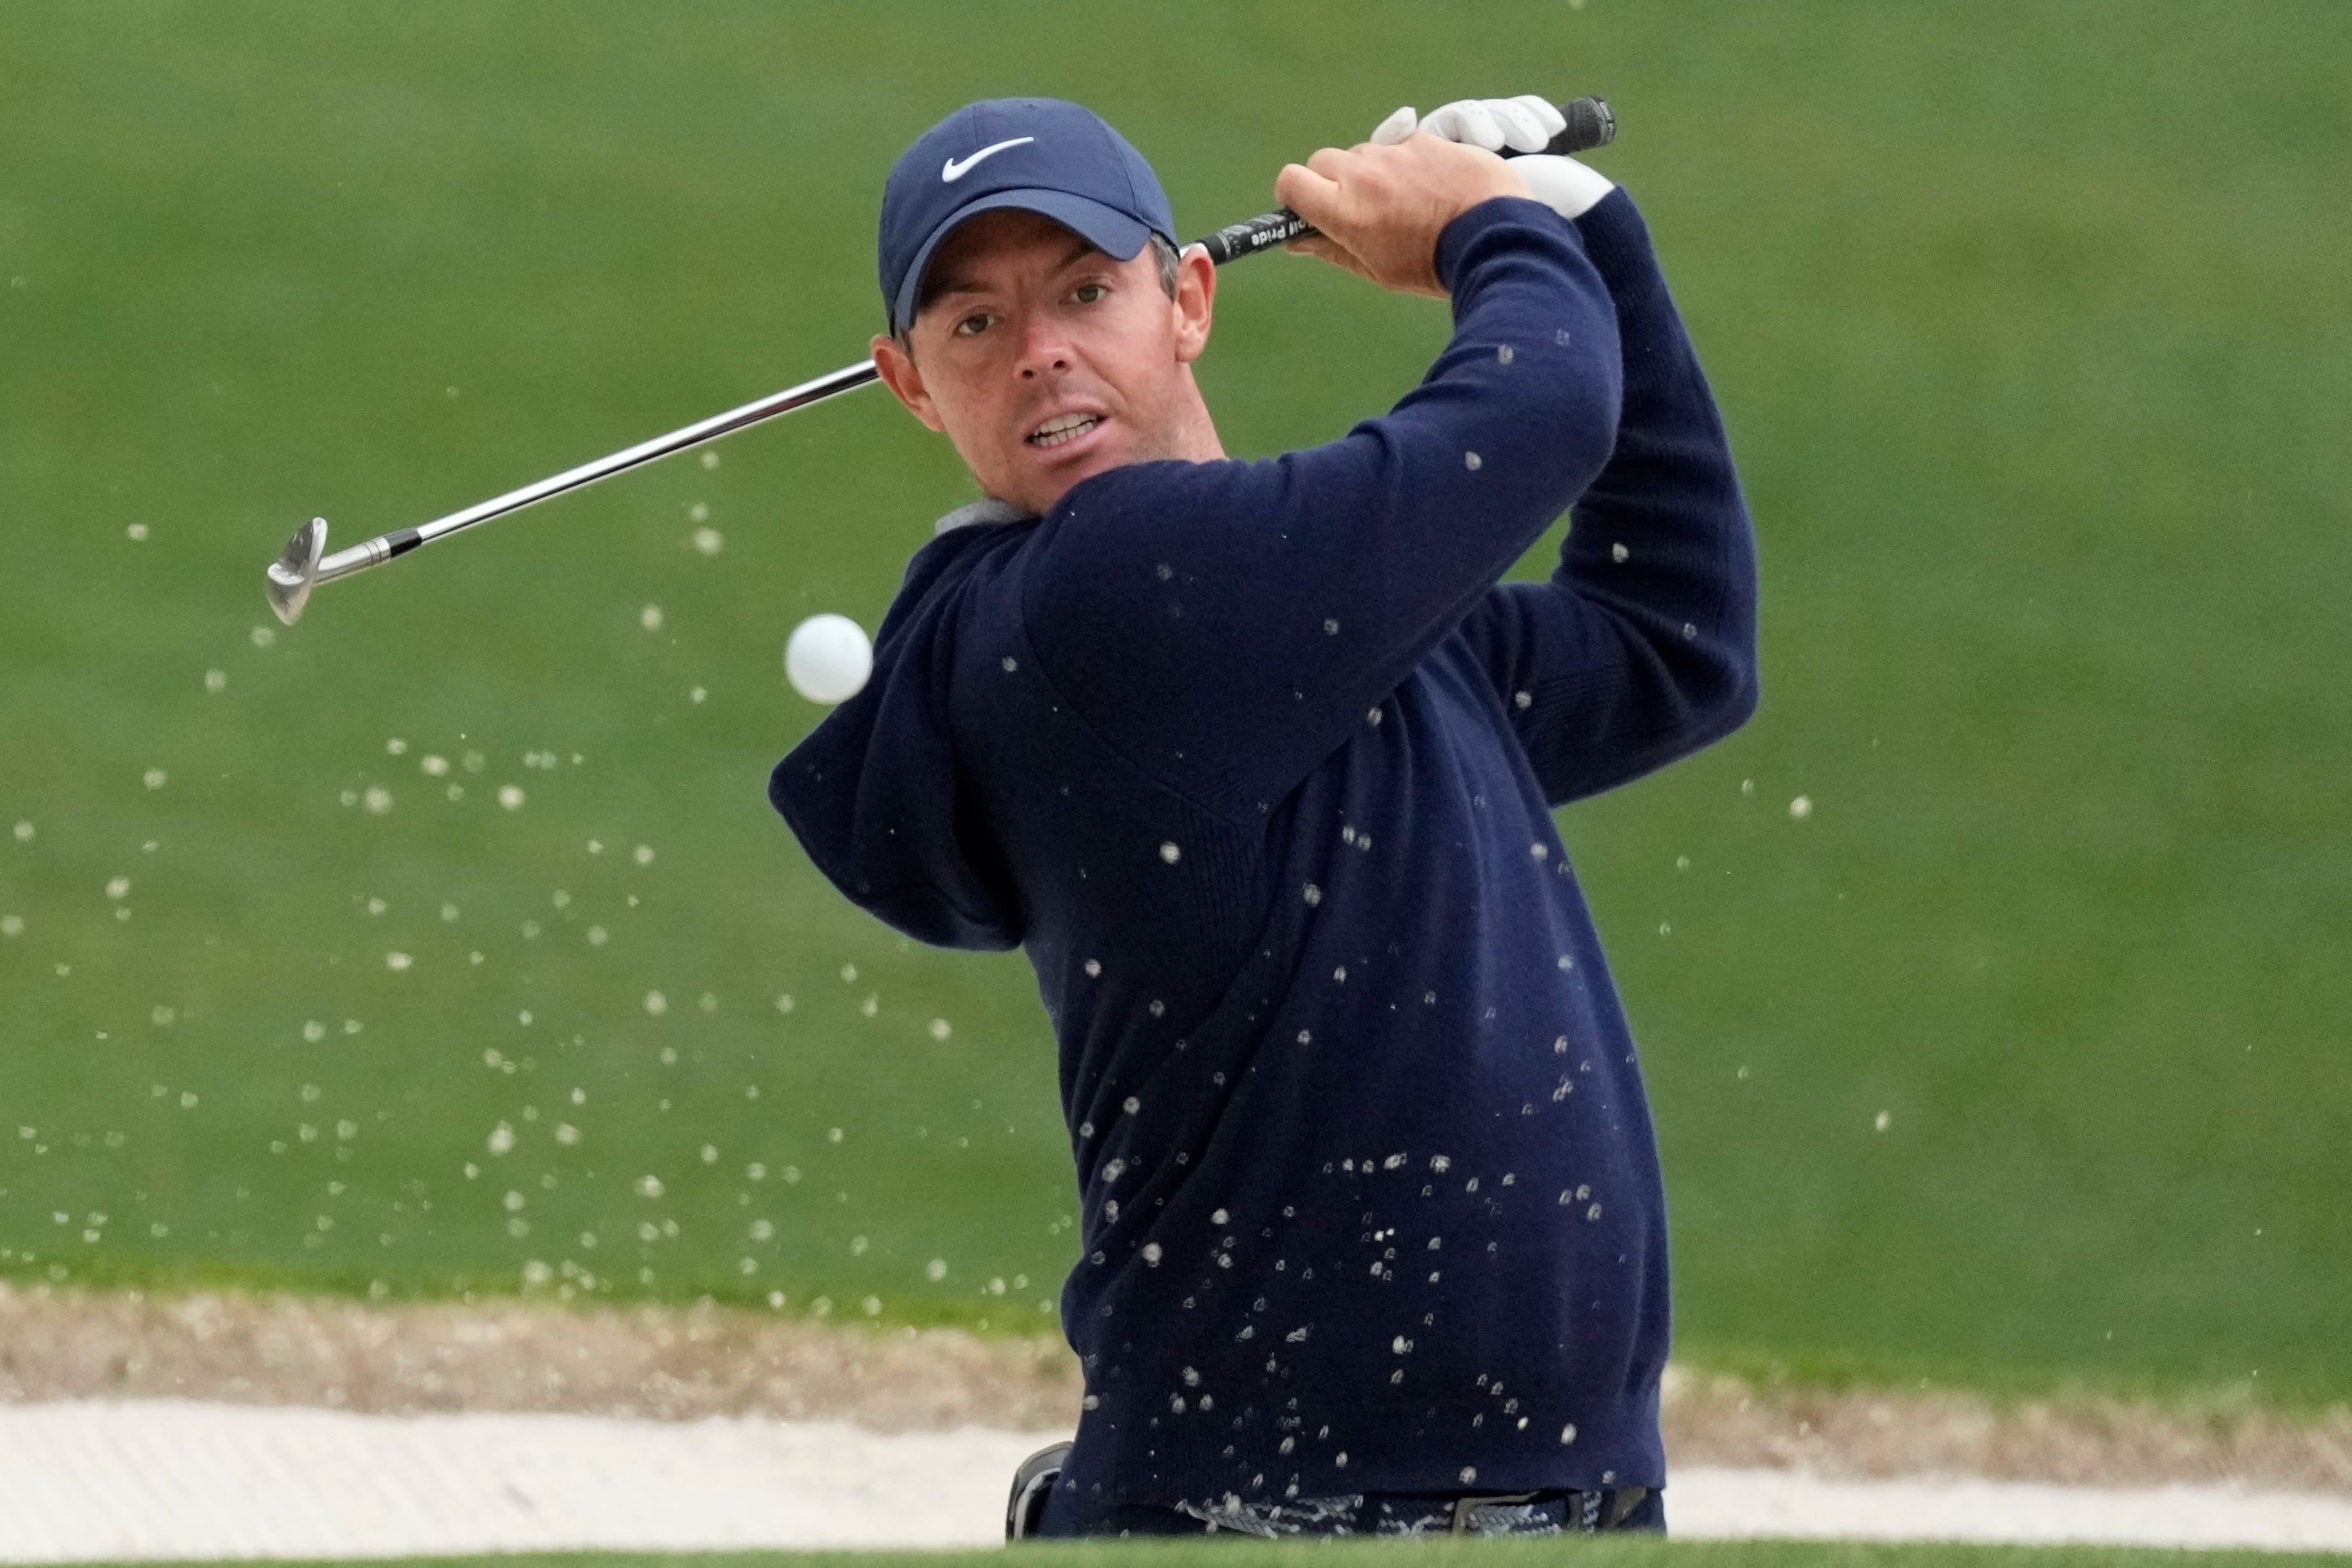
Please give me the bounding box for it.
[769,191,1757,1502]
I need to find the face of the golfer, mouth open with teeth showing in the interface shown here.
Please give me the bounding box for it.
[872,212,1218,515]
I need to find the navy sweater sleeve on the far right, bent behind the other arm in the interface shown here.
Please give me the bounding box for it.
[1463,191,1757,807]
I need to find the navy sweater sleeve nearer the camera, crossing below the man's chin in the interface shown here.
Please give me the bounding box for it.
[1023,198,1623,821]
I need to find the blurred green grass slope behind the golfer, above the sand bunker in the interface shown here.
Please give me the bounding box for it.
[0,0,2352,1406]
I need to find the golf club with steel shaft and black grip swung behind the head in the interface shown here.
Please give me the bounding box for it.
[268,96,1616,625]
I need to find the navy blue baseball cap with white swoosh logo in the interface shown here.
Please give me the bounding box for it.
[879,99,1176,329]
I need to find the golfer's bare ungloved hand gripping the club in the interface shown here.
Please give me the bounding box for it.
[1275,136,1529,299]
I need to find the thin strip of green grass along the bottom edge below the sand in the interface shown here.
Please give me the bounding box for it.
[91,1537,2345,1568]
